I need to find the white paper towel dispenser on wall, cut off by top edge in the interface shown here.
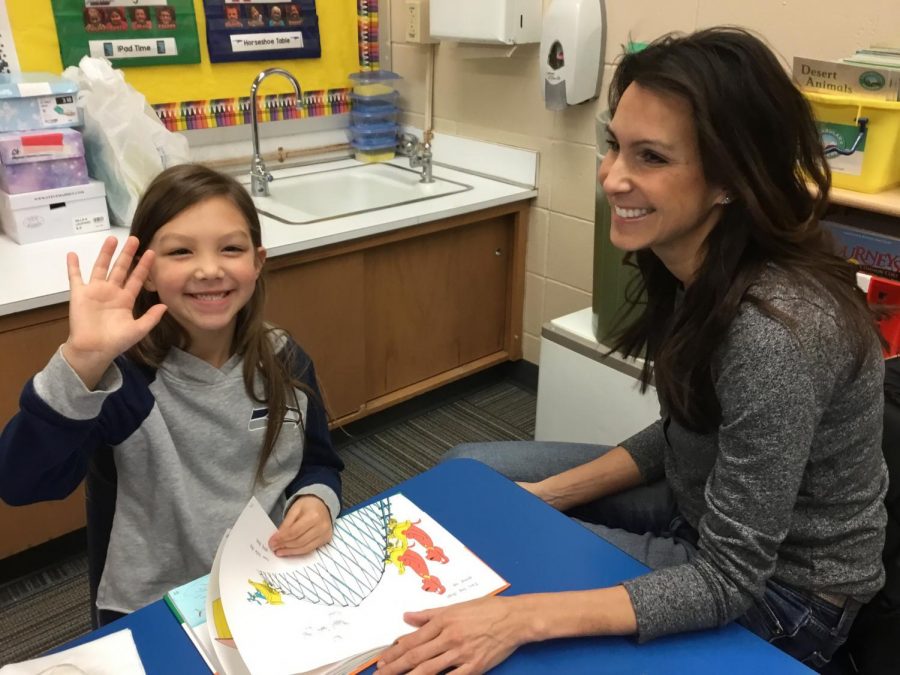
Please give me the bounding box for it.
[430,0,543,45]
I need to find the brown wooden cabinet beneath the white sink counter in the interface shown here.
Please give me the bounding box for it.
[0,202,529,558]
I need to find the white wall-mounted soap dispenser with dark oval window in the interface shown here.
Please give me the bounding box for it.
[541,0,606,110]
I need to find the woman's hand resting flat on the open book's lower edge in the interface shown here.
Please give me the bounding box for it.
[375,596,526,675]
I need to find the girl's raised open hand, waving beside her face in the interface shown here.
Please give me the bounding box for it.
[63,237,166,389]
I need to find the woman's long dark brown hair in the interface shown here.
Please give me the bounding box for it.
[609,28,874,432]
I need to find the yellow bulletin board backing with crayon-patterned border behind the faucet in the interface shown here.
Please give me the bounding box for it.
[6,0,378,130]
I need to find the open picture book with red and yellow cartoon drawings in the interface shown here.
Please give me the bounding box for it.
[166,494,508,675]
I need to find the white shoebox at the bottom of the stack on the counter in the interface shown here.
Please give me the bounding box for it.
[0,180,109,244]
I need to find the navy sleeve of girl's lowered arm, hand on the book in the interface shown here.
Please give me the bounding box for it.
[285,340,344,512]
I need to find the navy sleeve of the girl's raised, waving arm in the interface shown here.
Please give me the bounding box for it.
[0,356,154,506]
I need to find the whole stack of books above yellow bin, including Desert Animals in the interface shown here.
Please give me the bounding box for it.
[793,45,900,101]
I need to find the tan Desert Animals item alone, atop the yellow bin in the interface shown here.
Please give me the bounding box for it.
[793,56,900,101]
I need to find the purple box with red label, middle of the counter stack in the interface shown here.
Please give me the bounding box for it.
[0,129,90,194]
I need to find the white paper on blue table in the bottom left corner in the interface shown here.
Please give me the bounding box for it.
[0,628,145,675]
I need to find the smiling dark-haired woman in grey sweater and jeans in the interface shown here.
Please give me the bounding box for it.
[378,28,887,675]
